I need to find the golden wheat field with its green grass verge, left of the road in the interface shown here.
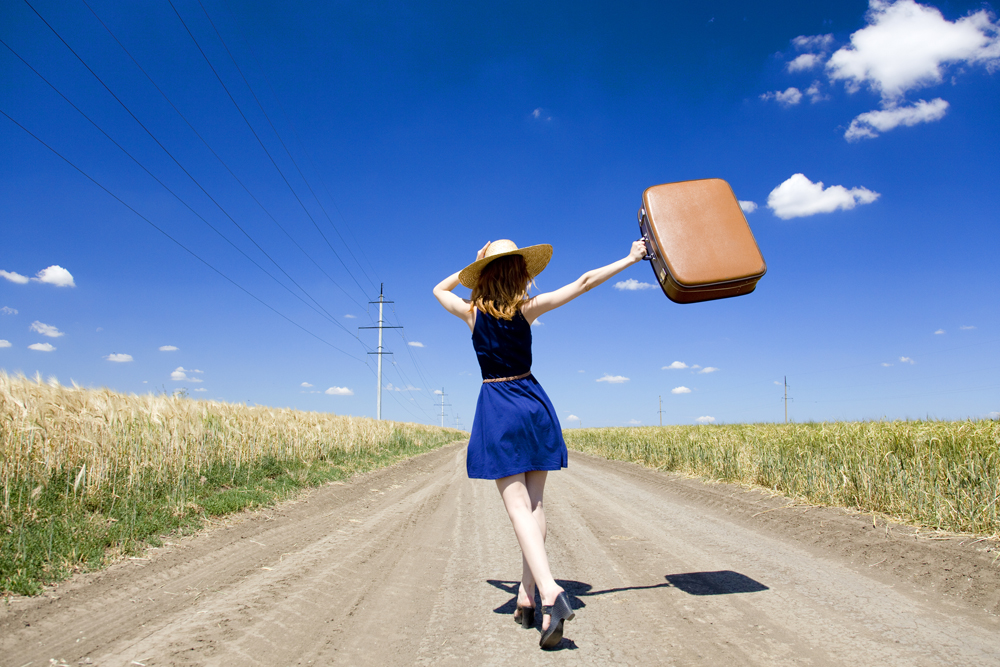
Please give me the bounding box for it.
[0,371,467,592]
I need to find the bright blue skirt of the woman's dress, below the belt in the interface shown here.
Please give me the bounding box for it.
[466,375,568,479]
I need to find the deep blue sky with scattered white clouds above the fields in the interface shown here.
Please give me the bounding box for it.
[0,0,1000,428]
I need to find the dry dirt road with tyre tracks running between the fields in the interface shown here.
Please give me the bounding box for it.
[0,445,1000,667]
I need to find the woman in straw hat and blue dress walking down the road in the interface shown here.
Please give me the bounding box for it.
[434,240,646,649]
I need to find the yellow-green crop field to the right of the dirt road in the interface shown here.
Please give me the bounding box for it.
[563,420,1000,535]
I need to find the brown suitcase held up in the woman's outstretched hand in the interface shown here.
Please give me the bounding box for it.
[639,178,767,303]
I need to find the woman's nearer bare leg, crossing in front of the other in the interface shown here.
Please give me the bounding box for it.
[497,471,563,630]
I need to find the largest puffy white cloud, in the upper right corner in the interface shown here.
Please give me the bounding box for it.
[826,0,1000,100]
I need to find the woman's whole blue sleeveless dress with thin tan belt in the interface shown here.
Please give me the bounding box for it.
[466,310,567,479]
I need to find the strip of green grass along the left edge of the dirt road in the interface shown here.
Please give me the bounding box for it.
[0,420,461,595]
